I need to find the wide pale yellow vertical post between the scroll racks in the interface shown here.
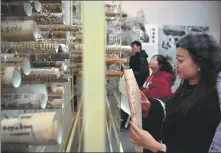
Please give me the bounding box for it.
[82,1,106,152]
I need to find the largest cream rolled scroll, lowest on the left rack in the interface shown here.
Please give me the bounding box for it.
[1,112,62,145]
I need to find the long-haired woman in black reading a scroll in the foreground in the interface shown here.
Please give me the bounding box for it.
[130,32,221,153]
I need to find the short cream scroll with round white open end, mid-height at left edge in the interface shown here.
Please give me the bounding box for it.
[1,67,21,88]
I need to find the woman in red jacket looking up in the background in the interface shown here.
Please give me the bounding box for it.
[140,55,176,133]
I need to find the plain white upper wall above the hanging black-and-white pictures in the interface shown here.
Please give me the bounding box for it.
[122,1,221,41]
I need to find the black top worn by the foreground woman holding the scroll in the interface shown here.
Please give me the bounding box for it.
[143,86,220,153]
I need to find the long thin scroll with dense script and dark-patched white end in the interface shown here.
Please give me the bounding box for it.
[1,41,67,53]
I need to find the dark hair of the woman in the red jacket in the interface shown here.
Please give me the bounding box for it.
[152,55,176,83]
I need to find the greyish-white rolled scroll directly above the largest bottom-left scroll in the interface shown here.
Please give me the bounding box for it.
[2,84,48,109]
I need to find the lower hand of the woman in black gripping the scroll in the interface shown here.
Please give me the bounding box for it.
[130,122,162,152]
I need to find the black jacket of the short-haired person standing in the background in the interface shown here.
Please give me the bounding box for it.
[129,50,150,87]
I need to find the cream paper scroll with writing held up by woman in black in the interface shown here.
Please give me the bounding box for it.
[124,69,143,152]
